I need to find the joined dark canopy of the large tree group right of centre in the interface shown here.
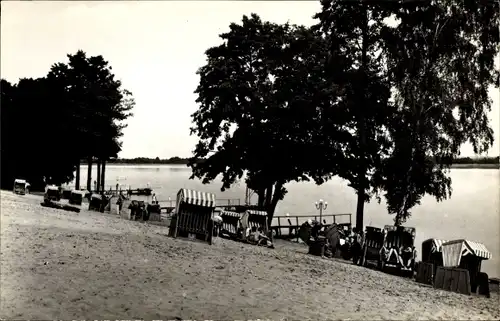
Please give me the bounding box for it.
[190,1,499,228]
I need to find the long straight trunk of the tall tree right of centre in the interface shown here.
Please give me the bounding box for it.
[356,4,368,231]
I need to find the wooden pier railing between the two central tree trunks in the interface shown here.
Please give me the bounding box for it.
[270,214,352,241]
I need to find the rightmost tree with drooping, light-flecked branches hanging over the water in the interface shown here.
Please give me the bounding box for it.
[376,1,500,225]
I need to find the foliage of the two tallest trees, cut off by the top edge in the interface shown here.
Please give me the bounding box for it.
[310,1,498,224]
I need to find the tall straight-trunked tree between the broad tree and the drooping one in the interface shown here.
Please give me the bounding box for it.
[313,0,393,229]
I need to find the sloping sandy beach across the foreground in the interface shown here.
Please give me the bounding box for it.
[0,191,500,320]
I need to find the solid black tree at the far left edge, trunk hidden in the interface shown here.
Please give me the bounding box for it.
[2,78,72,189]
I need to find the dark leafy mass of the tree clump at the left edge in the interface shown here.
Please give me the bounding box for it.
[1,51,134,189]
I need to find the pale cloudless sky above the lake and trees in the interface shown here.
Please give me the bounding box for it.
[0,1,500,158]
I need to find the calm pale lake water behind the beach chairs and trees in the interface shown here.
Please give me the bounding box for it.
[72,165,500,277]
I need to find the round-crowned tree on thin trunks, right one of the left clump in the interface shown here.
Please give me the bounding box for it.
[48,50,135,189]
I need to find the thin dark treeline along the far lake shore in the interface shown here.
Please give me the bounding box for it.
[82,156,500,165]
